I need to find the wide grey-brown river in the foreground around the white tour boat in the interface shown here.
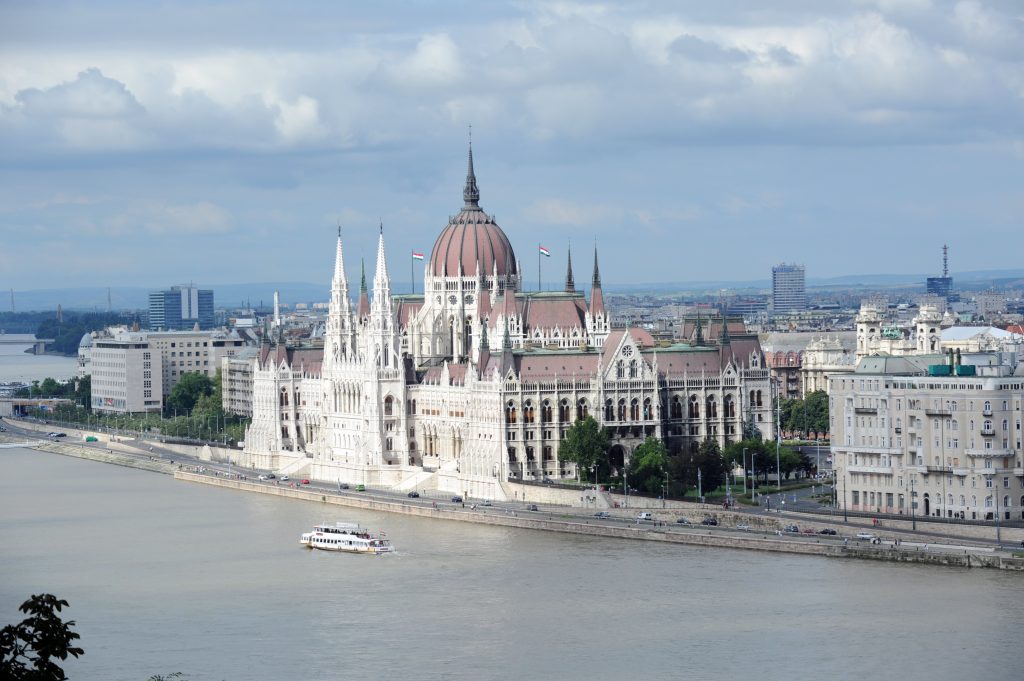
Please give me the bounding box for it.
[0,449,1024,681]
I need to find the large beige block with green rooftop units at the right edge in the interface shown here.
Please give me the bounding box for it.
[829,353,1024,520]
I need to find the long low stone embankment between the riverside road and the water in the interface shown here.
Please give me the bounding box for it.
[180,471,1024,571]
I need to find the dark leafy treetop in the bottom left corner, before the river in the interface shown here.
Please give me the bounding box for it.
[0,594,85,681]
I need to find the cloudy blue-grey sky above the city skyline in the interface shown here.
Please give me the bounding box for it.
[0,0,1024,290]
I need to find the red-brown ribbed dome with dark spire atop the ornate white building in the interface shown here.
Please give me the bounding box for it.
[430,146,517,278]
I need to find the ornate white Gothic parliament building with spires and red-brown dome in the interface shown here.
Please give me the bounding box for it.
[246,147,773,499]
